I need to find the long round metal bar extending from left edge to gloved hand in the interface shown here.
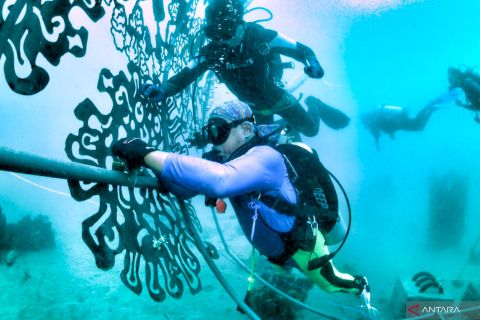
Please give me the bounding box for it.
[0,147,158,189]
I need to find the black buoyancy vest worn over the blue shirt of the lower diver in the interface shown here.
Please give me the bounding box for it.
[224,134,340,251]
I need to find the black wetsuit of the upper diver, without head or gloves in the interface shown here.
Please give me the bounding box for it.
[162,23,320,136]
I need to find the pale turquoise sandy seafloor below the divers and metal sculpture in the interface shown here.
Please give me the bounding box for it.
[0,189,480,320]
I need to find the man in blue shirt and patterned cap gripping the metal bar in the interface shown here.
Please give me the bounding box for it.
[112,101,370,299]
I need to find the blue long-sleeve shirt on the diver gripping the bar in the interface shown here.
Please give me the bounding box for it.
[161,146,296,257]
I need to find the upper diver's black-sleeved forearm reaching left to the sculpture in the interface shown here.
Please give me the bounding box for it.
[162,57,207,97]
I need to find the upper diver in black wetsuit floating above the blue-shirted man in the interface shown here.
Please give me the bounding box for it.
[140,0,349,137]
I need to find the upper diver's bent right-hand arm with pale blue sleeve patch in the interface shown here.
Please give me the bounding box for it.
[269,33,324,78]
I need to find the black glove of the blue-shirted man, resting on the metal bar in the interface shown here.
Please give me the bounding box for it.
[112,138,157,170]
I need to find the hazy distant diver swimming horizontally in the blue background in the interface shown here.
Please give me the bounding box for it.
[361,103,439,150]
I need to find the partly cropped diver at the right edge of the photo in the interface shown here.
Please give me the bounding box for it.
[448,67,480,123]
